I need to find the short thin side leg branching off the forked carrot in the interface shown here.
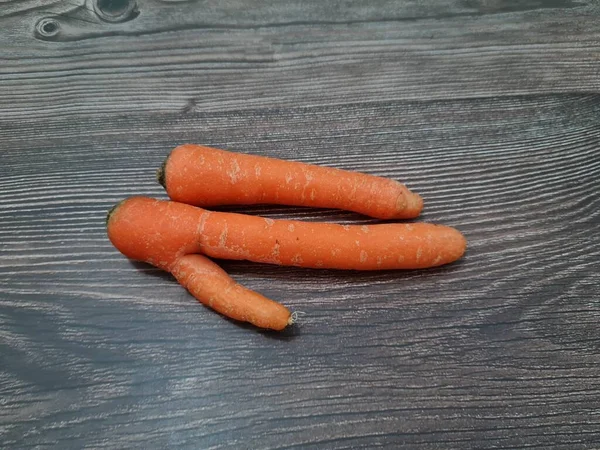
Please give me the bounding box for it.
[172,254,292,331]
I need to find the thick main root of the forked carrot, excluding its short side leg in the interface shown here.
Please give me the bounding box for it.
[108,197,466,271]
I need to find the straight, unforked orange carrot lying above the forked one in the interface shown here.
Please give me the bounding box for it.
[157,144,423,219]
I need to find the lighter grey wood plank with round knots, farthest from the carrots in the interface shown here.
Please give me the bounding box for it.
[0,1,600,120]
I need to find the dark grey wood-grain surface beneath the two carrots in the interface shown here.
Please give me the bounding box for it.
[0,0,600,449]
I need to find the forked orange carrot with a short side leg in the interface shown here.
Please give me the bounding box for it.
[107,197,466,330]
